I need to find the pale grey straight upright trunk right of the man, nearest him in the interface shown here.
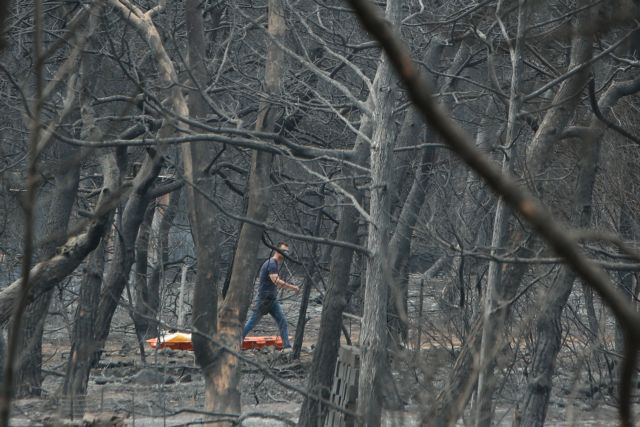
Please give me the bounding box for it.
[358,0,401,426]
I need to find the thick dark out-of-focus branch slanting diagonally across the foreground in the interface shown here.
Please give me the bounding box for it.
[350,0,640,427]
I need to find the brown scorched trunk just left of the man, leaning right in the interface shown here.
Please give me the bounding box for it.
[194,0,286,413]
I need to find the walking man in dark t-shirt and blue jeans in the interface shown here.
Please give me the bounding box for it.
[242,242,300,349]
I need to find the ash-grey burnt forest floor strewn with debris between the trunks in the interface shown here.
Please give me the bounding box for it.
[11,280,638,426]
